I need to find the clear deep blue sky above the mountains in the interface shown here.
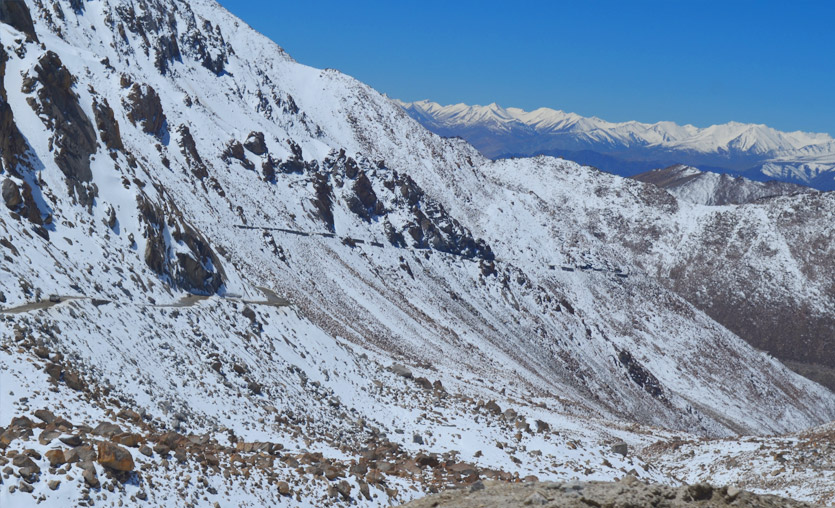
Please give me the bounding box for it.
[220,0,835,135]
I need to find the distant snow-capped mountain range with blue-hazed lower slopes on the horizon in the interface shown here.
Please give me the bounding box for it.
[398,100,835,190]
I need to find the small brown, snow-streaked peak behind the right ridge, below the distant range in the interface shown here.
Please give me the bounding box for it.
[632,164,815,206]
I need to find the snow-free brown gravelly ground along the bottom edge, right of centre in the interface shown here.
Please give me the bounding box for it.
[403,476,814,508]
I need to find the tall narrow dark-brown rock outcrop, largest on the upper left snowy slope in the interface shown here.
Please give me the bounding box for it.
[24,51,97,208]
